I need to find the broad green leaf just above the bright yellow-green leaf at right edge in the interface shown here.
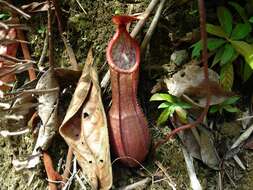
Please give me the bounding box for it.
[231,23,251,40]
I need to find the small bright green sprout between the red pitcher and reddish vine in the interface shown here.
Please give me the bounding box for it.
[150,93,191,125]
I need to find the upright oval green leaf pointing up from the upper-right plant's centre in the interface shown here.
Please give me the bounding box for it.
[217,6,233,36]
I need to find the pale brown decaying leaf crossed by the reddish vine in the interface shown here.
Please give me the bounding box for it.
[164,64,232,107]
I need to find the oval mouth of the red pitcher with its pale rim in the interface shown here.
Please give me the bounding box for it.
[106,29,140,73]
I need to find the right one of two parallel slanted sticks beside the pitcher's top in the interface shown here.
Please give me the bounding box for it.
[141,0,166,53]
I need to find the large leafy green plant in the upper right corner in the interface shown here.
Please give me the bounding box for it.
[192,2,253,87]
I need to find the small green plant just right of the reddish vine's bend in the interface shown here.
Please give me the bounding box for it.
[209,96,240,114]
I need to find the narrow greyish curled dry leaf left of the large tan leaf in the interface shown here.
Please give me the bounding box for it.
[13,69,59,170]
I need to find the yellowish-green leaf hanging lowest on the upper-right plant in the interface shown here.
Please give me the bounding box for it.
[220,62,234,91]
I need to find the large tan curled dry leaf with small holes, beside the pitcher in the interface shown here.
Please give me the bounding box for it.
[60,50,112,190]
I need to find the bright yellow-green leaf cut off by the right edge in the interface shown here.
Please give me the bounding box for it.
[230,40,253,69]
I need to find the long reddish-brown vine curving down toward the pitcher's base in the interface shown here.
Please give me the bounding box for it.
[154,0,211,150]
